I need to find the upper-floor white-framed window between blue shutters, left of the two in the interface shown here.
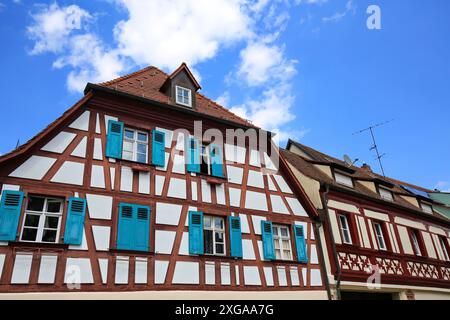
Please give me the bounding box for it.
[122,128,148,163]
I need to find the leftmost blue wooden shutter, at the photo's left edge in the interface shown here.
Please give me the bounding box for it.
[0,190,24,241]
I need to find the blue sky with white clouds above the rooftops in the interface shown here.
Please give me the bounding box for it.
[0,0,450,190]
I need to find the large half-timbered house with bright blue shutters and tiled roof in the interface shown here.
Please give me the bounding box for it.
[0,64,327,299]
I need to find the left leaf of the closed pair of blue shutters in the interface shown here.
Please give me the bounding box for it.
[117,203,135,250]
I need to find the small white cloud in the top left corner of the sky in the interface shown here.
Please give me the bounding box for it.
[27,2,91,54]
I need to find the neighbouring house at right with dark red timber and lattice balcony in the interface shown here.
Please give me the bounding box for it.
[282,141,450,299]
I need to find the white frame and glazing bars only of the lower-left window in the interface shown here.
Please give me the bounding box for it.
[20,196,64,243]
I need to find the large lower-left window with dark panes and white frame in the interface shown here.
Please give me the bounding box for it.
[21,196,63,243]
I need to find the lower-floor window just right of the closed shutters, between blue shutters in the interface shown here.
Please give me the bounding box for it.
[203,216,225,255]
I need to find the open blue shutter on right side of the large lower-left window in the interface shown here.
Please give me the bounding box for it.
[64,198,86,245]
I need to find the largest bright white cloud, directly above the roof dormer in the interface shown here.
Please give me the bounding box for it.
[114,0,251,69]
